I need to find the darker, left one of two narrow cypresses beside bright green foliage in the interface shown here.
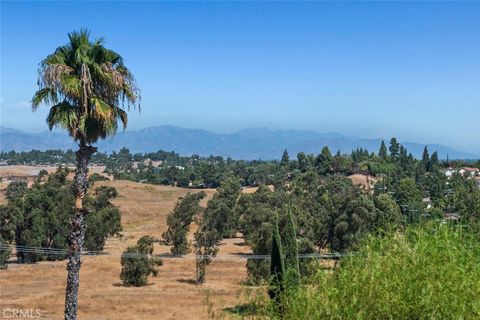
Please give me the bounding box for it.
[268,215,285,302]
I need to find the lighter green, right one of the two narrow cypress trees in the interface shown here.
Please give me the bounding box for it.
[284,209,300,286]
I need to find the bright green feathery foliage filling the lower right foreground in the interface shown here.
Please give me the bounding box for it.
[267,226,480,319]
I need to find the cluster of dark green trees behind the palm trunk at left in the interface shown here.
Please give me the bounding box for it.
[0,167,122,266]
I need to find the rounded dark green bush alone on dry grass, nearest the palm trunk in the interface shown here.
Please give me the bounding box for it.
[120,236,163,287]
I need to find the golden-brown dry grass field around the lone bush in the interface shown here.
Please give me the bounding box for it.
[0,176,251,320]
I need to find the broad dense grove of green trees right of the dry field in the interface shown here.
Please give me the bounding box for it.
[155,141,480,283]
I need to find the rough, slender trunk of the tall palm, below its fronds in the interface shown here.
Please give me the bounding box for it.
[65,141,97,320]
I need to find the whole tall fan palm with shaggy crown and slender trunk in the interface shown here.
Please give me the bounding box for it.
[32,30,140,320]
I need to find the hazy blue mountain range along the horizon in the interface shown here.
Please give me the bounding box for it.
[0,125,480,160]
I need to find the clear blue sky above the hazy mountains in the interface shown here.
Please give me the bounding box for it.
[0,1,480,151]
